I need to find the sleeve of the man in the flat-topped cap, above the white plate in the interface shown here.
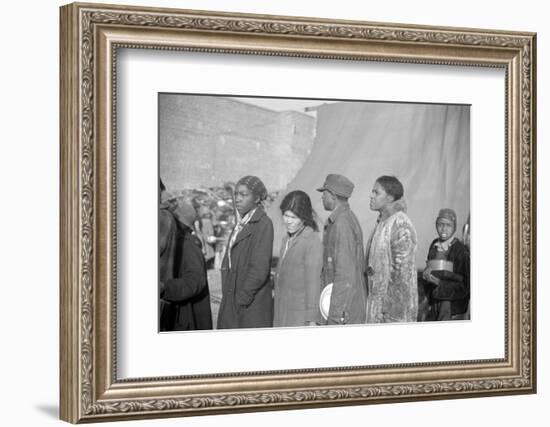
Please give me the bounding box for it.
[329,221,357,323]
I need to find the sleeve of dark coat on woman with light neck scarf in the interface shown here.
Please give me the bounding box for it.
[235,216,273,307]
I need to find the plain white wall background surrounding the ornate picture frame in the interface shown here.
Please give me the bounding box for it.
[0,0,550,427]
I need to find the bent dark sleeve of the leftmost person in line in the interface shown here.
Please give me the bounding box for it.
[162,239,207,302]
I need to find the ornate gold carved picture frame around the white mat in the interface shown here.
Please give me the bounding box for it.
[60,4,536,423]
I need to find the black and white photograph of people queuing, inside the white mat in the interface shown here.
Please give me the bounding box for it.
[158,92,476,332]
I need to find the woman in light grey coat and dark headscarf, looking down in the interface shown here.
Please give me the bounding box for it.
[273,191,323,327]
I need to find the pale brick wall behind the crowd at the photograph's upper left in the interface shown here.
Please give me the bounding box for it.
[159,94,315,191]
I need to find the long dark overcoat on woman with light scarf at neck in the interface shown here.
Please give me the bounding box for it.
[218,208,273,329]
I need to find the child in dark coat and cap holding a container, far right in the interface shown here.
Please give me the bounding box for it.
[422,208,470,320]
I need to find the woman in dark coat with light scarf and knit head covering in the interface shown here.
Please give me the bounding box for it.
[218,176,273,329]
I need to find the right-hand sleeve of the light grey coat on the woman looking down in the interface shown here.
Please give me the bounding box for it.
[304,233,323,322]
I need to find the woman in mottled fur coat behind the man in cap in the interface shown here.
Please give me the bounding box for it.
[367,176,418,323]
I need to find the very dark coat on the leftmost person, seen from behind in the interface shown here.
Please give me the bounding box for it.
[161,222,212,331]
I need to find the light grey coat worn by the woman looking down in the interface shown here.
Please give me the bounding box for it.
[273,227,323,327]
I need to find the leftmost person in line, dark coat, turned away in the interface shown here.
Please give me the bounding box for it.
[160,199,212,331]
